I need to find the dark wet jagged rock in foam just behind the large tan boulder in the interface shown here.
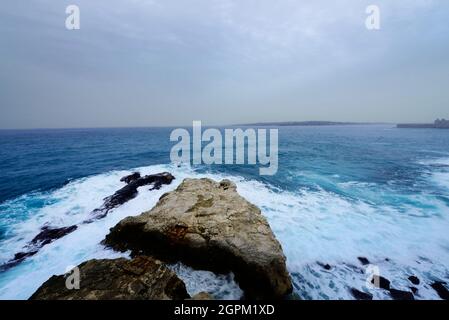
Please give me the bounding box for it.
[84,172,175,223]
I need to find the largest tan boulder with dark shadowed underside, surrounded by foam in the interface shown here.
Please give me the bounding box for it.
[104,179,292,299]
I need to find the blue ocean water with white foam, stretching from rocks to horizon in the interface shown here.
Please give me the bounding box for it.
[0,125,449,299]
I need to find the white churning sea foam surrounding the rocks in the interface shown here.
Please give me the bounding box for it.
[0,165,449,299]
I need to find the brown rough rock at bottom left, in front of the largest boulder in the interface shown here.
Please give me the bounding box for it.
[30,256,189,300]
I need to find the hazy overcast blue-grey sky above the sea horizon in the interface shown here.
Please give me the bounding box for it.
[0,0,449,129]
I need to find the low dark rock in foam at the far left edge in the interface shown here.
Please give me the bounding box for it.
[0,225,78,271]
